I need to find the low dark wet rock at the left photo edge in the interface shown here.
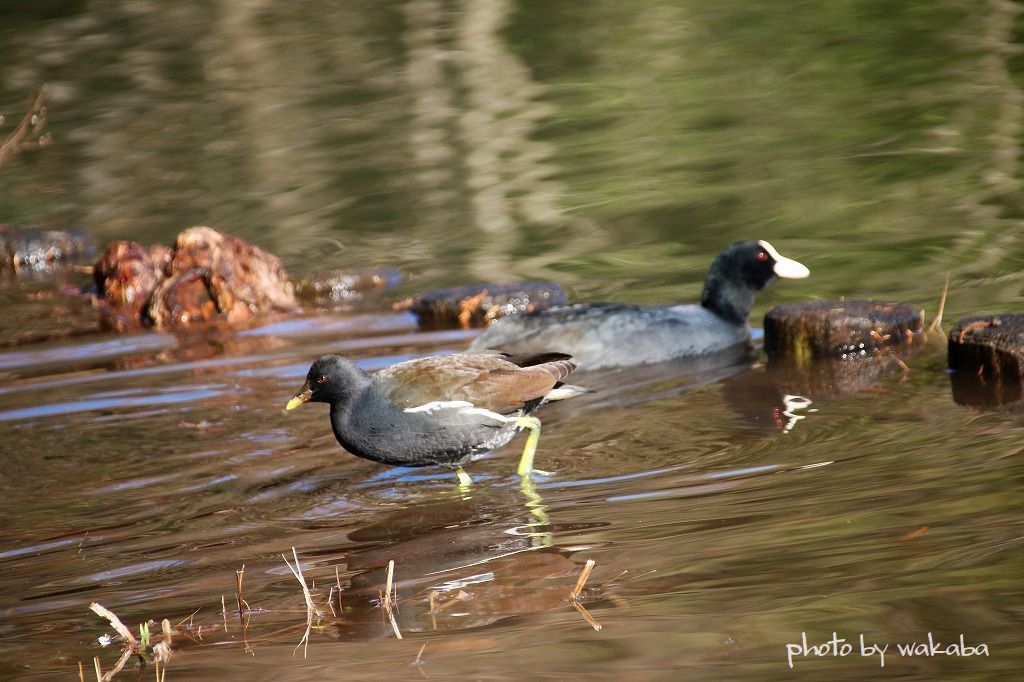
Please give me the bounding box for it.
[0,225,95,273]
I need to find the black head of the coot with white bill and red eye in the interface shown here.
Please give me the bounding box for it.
[700,241,810,326]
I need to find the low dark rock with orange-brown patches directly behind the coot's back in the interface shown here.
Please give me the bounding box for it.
[395,282,566,329]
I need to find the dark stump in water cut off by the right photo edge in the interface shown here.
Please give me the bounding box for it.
[948,312,1024,407]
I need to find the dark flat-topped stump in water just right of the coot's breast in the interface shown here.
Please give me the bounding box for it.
[765,301,923,364]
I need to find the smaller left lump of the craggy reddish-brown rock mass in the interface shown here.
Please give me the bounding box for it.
[92,241,173,332]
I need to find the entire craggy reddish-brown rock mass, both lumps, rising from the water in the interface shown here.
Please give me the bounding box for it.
[94,226,298,331]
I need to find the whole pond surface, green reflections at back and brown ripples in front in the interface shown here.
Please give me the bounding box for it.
[0,0,1024,682]
